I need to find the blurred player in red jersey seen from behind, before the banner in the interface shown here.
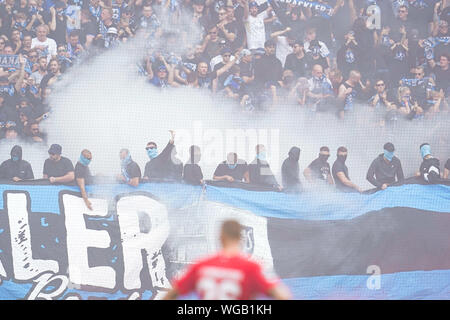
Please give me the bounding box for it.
[164,220,291,300]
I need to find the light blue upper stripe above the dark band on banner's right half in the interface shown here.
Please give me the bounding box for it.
[207,184,450,220]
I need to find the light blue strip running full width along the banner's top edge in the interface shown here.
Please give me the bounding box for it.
[0,183,450,220]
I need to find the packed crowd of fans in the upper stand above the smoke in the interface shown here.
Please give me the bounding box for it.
[0,0,444,143]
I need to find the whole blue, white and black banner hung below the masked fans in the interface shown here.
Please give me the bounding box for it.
[0,183,450,299]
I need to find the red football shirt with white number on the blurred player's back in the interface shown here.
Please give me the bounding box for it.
[173,253,279,300]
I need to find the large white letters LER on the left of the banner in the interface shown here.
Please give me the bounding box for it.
[0,191,174,299]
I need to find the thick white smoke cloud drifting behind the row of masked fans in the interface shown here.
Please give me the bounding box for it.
[33,30,450,188]
